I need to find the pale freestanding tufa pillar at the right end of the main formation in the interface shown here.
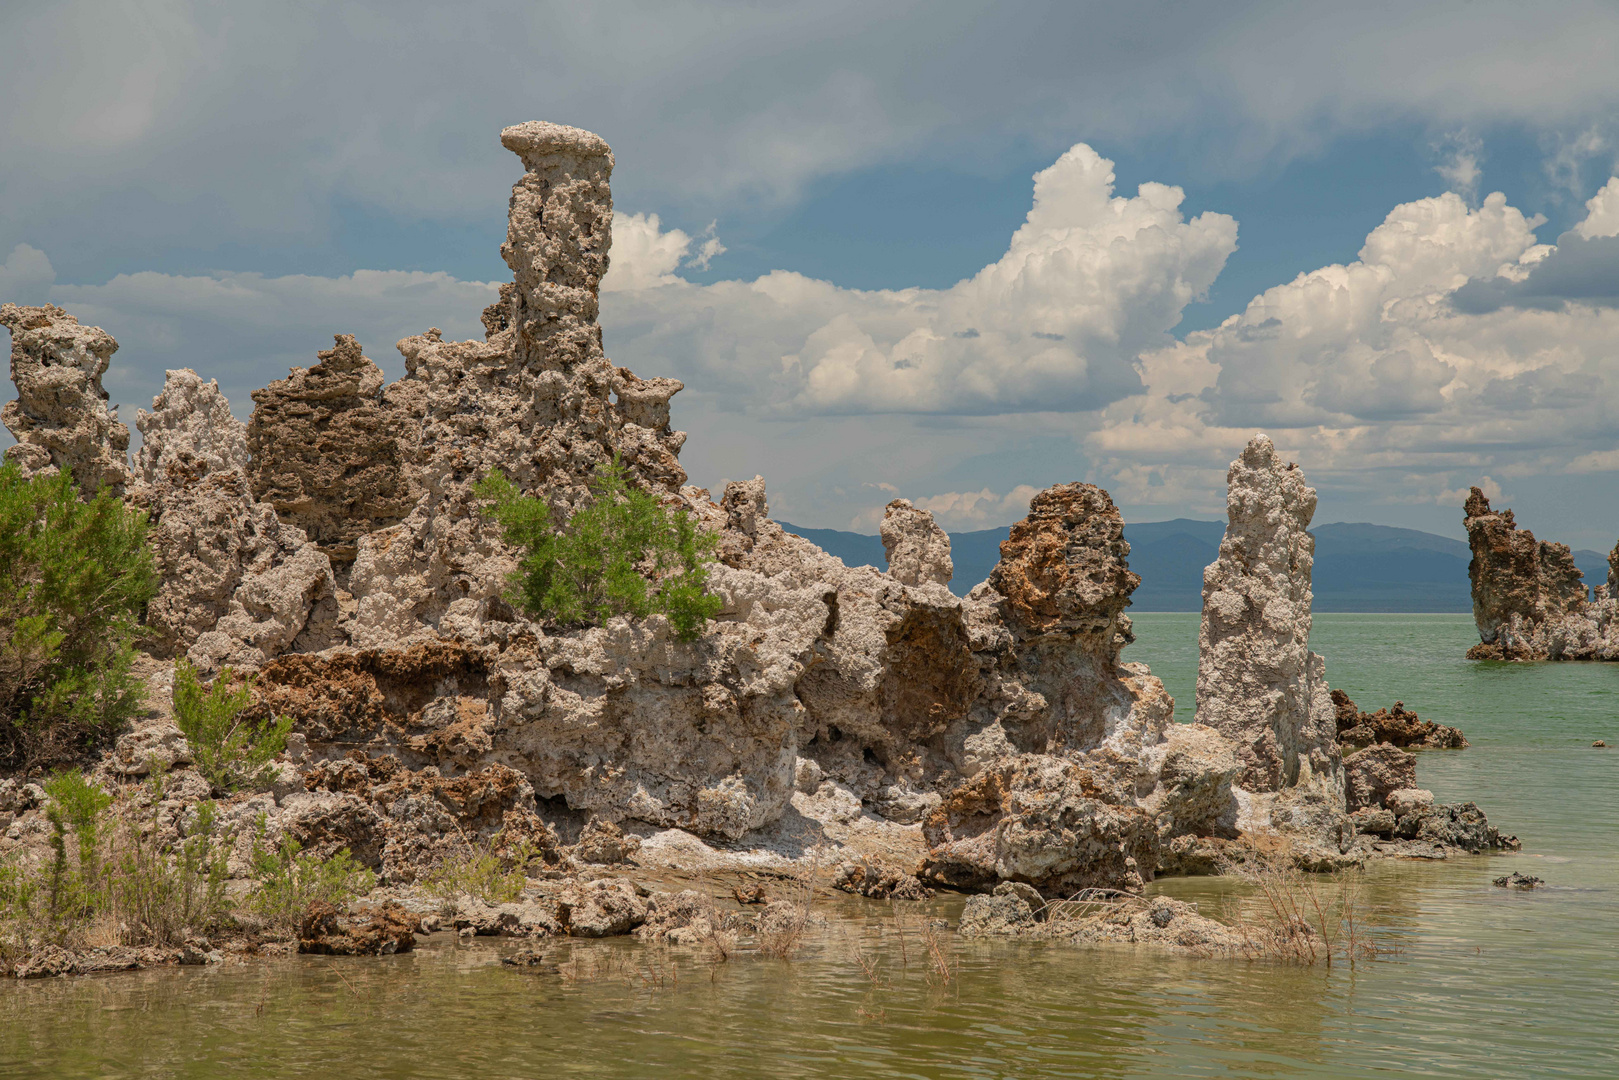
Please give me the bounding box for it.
[1196,436,1344,829]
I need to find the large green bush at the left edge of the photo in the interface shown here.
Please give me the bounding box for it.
[0,465,159,767]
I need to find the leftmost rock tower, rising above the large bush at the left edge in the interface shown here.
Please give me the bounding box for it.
[0,304,130,499]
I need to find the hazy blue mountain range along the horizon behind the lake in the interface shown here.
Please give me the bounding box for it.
[780,518,1608,612]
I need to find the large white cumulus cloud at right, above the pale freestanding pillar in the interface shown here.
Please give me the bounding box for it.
[1085,172,1619,514]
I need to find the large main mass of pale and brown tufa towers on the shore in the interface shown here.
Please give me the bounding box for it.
[0,123,1515,932]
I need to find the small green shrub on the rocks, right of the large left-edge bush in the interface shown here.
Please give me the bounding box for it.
[175,661,293,792]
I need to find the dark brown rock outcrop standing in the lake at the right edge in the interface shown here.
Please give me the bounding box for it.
[1464,487,1619,661]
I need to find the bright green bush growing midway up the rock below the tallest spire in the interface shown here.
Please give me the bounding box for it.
[476,458,722,641]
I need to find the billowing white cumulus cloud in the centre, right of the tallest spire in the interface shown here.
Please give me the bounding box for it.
[604,144,1237,416]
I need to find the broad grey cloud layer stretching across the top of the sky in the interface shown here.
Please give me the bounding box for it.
[0,0,1619,277]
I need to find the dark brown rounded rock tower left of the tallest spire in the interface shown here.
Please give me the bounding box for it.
[248,334,416,563]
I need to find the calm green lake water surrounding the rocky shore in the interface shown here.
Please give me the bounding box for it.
[0,614,1619,1078]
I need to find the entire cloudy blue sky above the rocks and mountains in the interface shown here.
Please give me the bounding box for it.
[0,0,1619,551]
